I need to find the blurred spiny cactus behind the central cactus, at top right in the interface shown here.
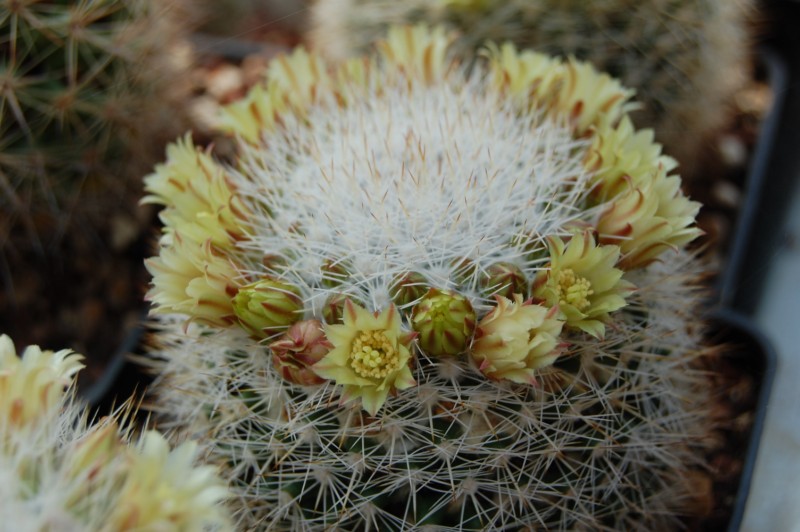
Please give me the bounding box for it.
[310,0,752,176]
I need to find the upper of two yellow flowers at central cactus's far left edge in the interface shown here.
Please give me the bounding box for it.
[142,135,244,247]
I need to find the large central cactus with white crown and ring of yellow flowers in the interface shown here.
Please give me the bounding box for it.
[145,26,708,530]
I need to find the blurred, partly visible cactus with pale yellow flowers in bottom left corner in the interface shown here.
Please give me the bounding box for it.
[0,335,230,531]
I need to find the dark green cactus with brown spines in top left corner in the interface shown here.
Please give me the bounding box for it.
[0,0,190,237]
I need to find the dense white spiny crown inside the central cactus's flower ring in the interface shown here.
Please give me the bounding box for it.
[232,80,592,309]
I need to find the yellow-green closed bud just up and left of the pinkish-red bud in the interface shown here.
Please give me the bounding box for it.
[233,279,303,340]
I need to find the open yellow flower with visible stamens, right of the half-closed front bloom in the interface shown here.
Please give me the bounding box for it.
[533,231,633,338]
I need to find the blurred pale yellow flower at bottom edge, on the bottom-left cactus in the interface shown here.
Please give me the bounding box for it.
[108,431,232,531]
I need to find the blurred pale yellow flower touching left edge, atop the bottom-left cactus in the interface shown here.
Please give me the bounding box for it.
[0,334,84,428]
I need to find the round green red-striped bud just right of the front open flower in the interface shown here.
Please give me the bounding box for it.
[412,288,475,356]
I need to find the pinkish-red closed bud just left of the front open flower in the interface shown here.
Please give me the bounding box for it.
[269,320,333,386]
